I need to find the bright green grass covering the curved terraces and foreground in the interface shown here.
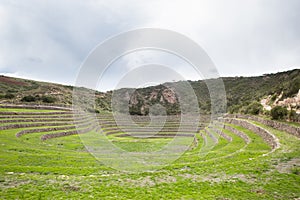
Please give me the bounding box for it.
[0,109,300,200]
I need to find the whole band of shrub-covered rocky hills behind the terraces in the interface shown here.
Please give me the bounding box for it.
[0,69,300,115]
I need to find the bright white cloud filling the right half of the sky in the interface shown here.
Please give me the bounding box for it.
[141,0,300,75]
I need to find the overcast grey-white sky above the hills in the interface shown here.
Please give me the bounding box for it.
[0,0,300,90]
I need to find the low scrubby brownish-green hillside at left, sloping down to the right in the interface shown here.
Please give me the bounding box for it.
[0,76,110,109]
